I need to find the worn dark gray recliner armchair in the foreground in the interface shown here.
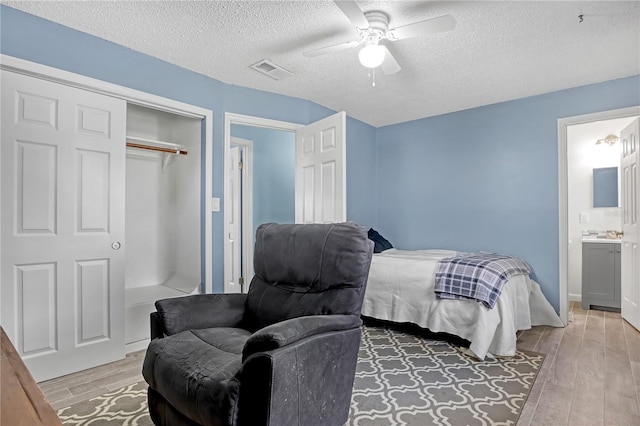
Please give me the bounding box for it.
[142,223,373,426]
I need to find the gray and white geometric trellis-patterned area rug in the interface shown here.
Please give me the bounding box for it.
[58,325,544,426]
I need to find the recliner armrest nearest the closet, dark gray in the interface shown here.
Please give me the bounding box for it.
[151,294,247,338]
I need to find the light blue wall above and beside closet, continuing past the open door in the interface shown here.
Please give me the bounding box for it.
[0,5,375,292]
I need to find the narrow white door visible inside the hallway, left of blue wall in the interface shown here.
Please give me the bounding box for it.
[224,146,242,293]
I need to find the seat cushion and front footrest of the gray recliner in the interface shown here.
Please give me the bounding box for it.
[142,327,251,424]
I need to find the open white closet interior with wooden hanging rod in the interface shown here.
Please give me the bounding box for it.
[125,103,204,351]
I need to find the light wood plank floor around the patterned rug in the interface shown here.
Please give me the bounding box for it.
[39,303,640,426]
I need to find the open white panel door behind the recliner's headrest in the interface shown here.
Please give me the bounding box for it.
[295,111,347,223]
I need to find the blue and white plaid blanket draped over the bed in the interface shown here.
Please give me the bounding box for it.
[435,252,531,309]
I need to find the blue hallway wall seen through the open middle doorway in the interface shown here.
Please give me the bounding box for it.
[231,124,296,236]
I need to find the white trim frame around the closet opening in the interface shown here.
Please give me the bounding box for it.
[0,55,213,293]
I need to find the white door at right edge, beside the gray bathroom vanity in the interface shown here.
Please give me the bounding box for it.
[620,118,640,330]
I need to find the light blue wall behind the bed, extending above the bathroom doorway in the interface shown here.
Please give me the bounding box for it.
[375,76,640,309]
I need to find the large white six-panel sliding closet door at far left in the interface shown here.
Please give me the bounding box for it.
[0,71,126,381]
